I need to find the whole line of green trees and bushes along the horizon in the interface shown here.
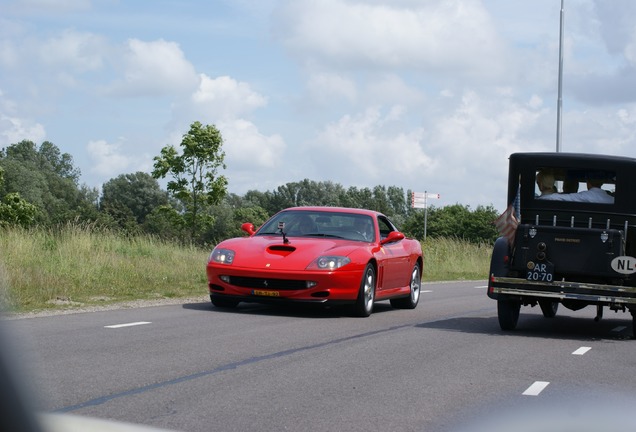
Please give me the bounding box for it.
[0,122,497,246]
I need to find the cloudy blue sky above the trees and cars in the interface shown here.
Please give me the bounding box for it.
[0,0,636,210]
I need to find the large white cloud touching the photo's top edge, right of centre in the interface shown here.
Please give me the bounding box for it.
[276,0,503,78]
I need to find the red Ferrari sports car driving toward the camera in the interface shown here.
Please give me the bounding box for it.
[207,207,423,317]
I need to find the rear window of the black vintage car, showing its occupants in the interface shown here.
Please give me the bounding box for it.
[534,167,617,204]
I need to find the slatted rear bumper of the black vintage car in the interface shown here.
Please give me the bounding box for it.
[488,277,636,309]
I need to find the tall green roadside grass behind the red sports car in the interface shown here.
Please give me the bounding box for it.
[0,224,491,312]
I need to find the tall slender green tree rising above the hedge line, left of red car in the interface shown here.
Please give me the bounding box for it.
[152,121,227,241]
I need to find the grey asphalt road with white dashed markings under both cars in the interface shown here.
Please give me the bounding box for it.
[2,281,636,432]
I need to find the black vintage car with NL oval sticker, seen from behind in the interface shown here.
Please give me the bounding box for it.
[488,153,636,335]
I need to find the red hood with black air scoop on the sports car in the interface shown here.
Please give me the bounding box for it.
[217,236,369,270]
